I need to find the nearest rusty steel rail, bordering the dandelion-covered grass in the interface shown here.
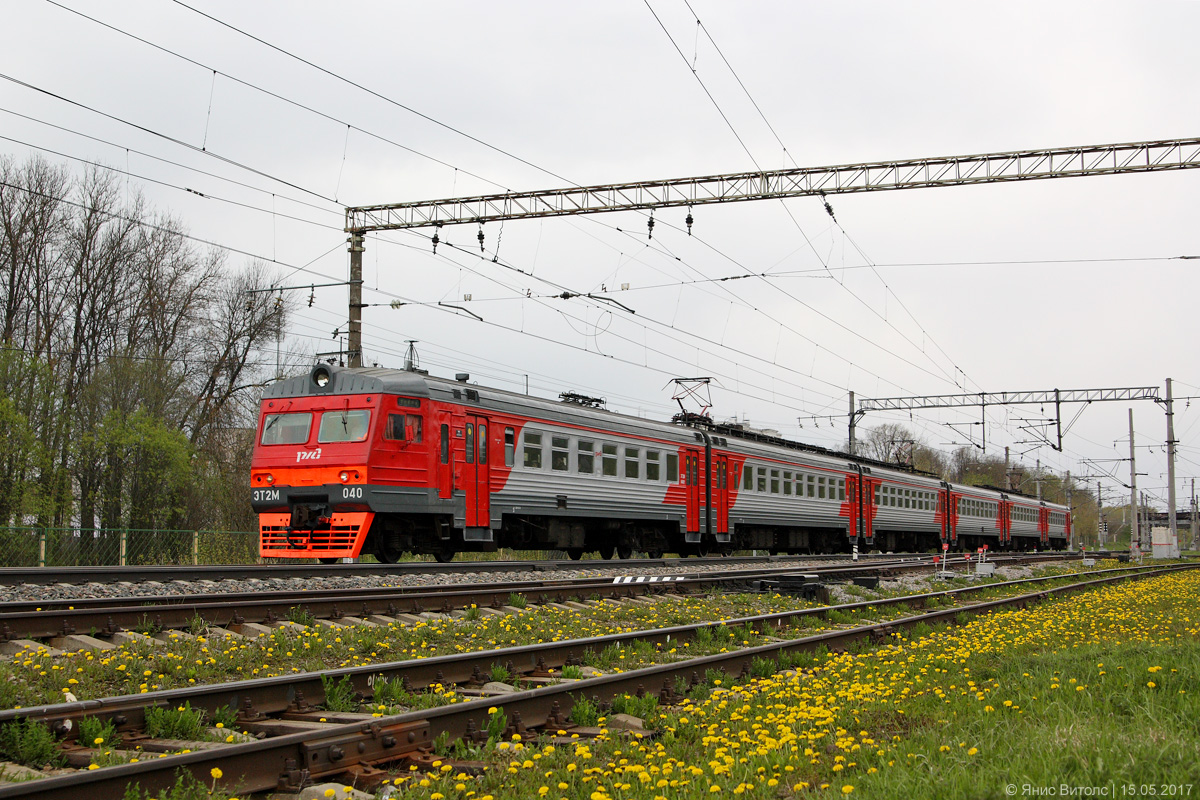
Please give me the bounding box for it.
[0,565,1180,800]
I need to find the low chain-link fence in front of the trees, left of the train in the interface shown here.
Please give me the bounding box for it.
[0,527,260,567]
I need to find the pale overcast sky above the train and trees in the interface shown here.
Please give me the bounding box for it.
[0,0,1200,505]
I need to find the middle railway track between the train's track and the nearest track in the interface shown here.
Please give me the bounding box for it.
[0,554,1070,654]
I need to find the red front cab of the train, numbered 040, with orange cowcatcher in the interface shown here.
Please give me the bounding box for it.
[251,366,437,563]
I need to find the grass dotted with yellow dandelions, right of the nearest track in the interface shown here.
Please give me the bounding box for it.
[367,573,1200,800]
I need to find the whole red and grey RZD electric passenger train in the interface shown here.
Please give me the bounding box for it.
[250,365,1070,563]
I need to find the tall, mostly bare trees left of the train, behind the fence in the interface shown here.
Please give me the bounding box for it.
[0,157,288,544]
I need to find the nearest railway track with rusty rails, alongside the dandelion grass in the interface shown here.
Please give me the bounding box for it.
[0,565,1180,800]
